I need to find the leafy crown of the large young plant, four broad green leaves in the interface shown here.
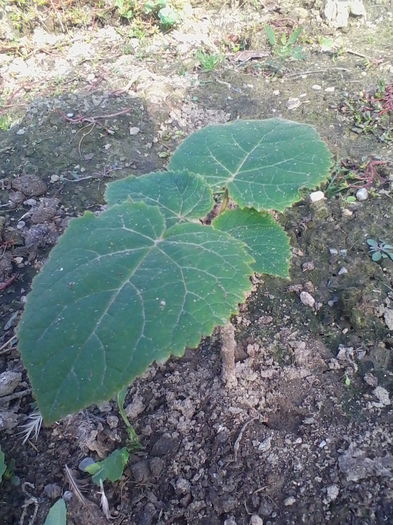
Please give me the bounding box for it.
[18,119,331,423]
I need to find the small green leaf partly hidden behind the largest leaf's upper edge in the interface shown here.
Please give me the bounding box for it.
[105,172,214,226]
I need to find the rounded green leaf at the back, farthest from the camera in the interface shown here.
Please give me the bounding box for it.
[169,119,331,211]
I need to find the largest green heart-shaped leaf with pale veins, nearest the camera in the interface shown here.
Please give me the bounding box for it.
[18,202,253,422]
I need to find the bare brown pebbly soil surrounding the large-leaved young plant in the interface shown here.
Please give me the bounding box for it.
[0,1,393,525]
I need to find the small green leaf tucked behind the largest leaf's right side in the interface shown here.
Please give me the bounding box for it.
[213,208,291,277]
